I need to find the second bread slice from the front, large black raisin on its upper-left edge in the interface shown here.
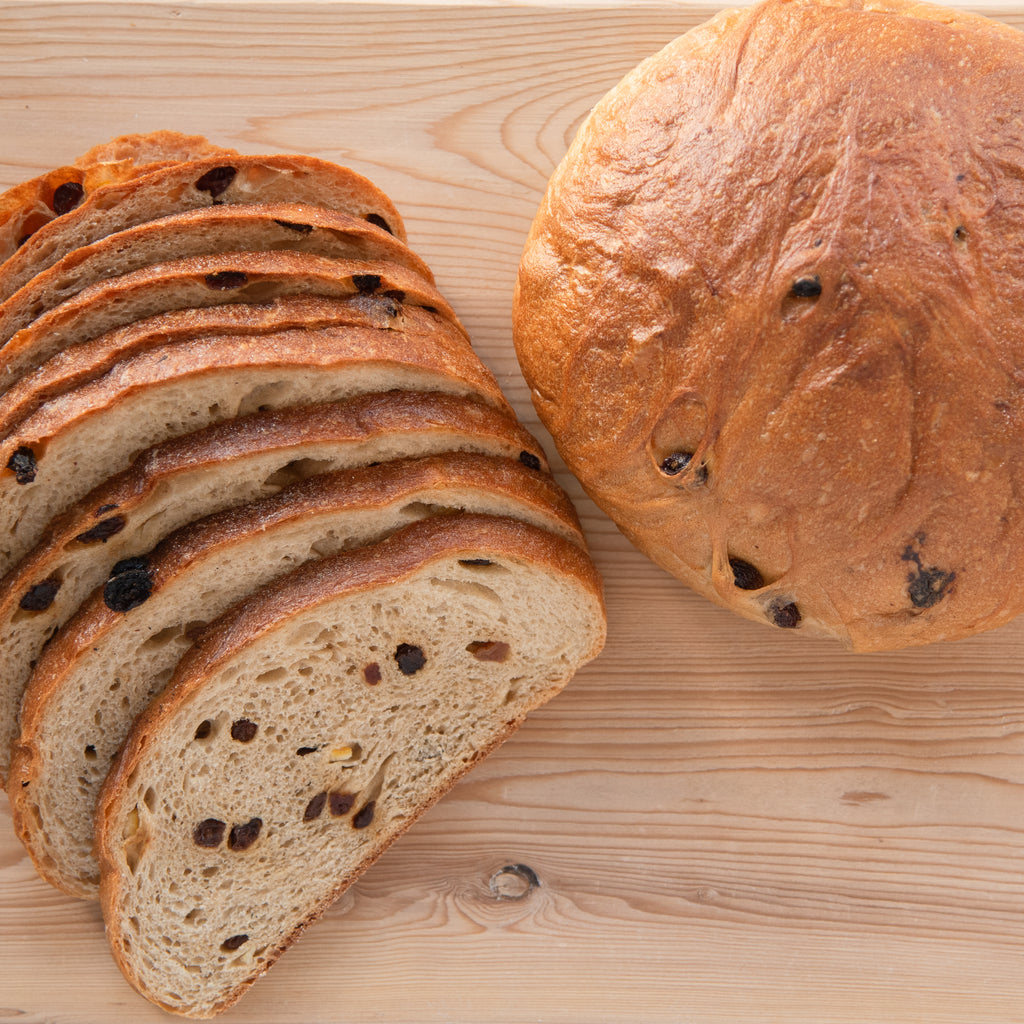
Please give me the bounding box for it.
[8,453,585,899]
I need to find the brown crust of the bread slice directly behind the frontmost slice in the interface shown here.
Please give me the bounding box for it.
[7,453,586,899]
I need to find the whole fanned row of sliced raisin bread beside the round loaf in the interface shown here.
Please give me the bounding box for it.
[0,132,605,1017]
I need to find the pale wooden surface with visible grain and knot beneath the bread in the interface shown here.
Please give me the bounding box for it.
[0,0,1024,1024]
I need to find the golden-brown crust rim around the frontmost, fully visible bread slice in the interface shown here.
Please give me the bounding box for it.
[96,515,604,1018]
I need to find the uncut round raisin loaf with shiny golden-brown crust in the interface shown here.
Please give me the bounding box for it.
[515,0,1024,650]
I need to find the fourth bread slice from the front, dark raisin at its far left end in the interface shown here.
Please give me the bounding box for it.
[0,308,511,571]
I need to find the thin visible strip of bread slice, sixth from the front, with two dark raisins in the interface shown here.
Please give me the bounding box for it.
[0,252,469,390]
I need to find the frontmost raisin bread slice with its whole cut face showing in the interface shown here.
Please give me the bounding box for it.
[97,515,604,1018]
